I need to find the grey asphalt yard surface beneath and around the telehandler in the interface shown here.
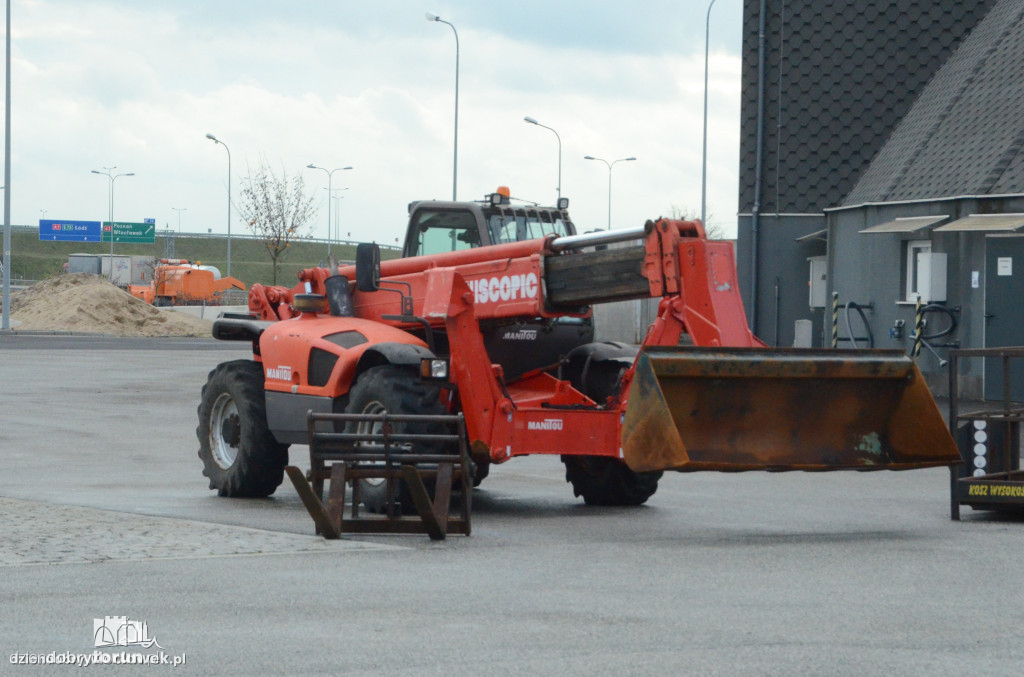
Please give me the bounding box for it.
[0,335,1024,676]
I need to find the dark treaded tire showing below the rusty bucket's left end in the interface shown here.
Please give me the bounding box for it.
[562,456,662,506]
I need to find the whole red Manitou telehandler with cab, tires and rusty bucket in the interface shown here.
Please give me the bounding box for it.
[197,187,959,524]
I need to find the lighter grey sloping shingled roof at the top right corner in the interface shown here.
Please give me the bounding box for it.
[843,0,1024,206]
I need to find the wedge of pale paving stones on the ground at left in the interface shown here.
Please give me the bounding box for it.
[0,498,402,566]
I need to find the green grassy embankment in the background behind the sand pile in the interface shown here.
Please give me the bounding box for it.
[10,226,398,287]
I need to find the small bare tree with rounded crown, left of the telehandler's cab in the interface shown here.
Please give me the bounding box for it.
[239,160,316,285]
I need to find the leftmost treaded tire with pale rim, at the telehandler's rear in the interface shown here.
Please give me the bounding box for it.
[196,359,288,498]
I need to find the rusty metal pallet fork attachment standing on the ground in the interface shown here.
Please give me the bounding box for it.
[285,412,472,541]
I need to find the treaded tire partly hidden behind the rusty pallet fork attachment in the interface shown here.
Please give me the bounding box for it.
[345,365,451,512]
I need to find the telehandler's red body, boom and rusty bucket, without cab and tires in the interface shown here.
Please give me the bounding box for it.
[235,219,958,472]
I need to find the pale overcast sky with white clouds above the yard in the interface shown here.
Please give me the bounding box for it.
[11,0,741,244]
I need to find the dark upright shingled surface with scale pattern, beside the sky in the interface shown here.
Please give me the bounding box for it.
[739,0,991,213]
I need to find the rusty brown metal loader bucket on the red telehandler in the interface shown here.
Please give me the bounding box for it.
[622,347,961,472]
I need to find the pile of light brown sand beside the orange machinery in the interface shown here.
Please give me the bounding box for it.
[4,272,213,337]
